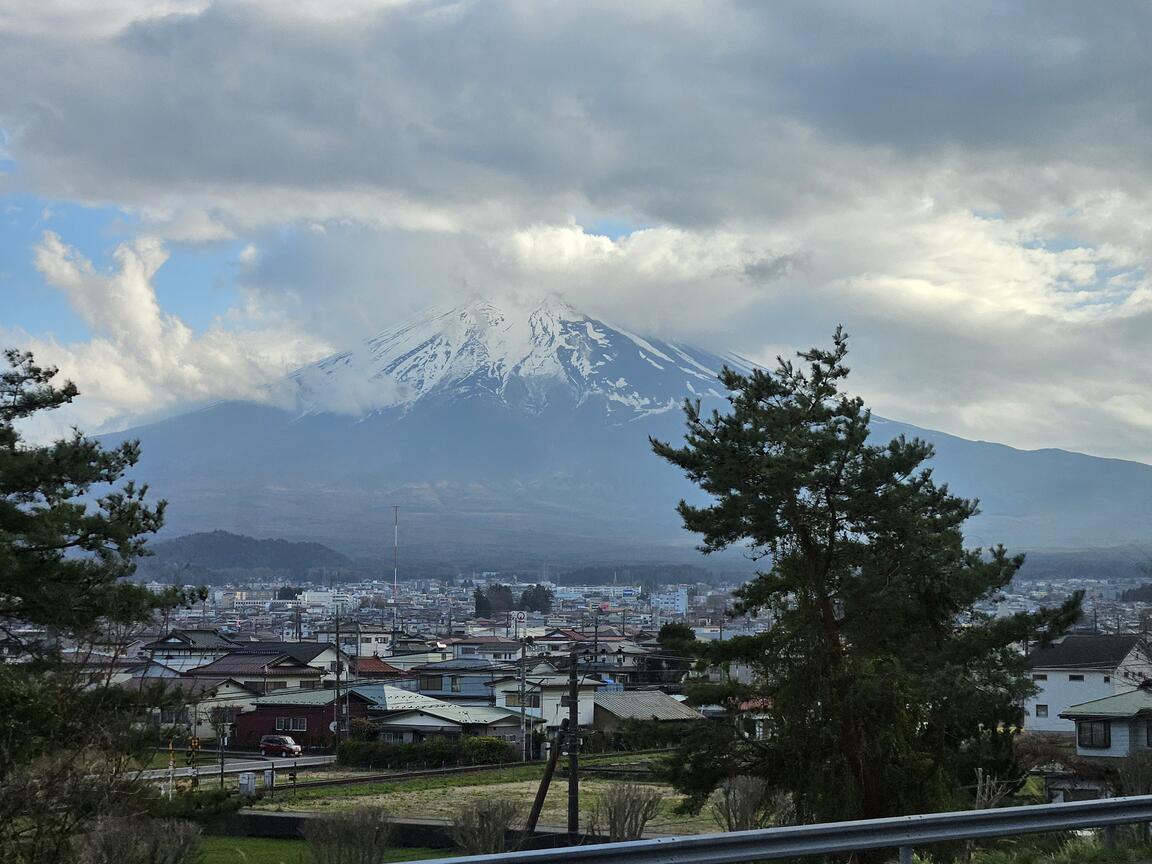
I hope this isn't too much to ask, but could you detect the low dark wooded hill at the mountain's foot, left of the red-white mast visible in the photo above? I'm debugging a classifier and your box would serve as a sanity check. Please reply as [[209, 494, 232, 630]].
[[151, 531, 353, 573]]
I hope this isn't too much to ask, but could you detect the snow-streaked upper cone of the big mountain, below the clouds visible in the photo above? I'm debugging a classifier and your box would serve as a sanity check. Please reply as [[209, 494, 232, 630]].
[[293, 298, 750, 423]]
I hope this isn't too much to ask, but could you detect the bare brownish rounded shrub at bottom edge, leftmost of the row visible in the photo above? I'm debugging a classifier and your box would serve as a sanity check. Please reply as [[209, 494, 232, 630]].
[[76, 817, 200, 864]]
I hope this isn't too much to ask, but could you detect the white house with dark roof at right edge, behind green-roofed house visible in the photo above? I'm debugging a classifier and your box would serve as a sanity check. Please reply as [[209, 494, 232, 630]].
[[1024, 634, 1152, 735]]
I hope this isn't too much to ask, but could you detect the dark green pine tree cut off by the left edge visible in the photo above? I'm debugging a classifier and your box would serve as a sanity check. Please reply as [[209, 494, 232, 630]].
[[0, 350, 170, 634]]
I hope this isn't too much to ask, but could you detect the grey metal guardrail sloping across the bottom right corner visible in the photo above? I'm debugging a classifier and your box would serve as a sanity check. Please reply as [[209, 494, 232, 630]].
[[426, 795, 1152, 864]]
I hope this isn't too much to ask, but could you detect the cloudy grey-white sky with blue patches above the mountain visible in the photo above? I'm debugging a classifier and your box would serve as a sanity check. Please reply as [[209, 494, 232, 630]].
[[0, 0, 1152, 461]]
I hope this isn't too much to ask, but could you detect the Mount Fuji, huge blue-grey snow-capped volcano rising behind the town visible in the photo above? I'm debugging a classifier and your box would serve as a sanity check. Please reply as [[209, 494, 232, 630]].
[[105, 300, 1152, 566]]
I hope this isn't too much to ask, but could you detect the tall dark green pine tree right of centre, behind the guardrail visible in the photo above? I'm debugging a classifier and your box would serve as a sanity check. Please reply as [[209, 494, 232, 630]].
[[652, 328, 1079, 821]]
